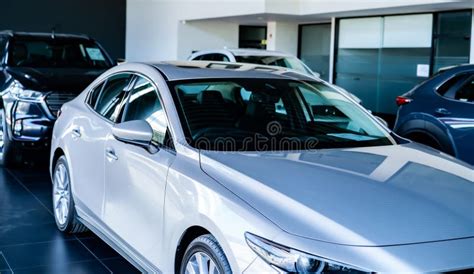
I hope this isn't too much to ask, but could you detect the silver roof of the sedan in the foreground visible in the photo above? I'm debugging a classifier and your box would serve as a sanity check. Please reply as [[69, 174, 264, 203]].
[[151, 61, 315, 81]]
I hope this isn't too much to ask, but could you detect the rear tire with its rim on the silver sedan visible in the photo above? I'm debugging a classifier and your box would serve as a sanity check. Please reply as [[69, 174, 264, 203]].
[[52, 156, 87, 234]]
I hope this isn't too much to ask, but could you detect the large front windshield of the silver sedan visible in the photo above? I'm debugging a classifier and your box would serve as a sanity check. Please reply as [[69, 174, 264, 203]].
[[170, 78, 395, 151]]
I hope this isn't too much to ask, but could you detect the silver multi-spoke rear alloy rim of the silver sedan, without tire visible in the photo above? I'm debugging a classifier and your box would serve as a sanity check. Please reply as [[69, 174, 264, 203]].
[[53, 163, 71, 226]]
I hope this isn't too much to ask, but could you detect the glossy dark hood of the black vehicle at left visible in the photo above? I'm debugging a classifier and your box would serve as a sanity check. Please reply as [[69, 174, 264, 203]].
[[7, 67, 104, 93]]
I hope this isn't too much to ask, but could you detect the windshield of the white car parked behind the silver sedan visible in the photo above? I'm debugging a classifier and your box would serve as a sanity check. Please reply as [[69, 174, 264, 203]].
[[235, 56, 313, 75]]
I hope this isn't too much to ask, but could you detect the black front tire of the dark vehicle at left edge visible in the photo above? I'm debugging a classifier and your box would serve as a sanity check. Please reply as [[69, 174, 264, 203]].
[[1, 109, 23, 168]]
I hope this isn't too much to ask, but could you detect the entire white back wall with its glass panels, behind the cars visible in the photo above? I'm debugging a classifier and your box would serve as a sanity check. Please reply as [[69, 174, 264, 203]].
[[126, 0, 474, 115]]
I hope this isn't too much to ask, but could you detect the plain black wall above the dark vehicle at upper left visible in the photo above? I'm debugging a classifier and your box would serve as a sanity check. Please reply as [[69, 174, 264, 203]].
[[0, 0, 126, 58]]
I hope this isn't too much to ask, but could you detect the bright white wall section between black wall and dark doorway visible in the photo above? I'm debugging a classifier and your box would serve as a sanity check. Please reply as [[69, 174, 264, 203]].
[[125, 0, 265, 61]]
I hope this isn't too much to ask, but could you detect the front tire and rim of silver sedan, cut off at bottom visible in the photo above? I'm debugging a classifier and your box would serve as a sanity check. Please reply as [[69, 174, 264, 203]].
[[179, 234, 232, 274]]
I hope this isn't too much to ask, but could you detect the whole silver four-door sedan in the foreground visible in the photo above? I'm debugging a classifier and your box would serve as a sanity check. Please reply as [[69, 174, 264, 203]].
[[51, 62, 474, 273]]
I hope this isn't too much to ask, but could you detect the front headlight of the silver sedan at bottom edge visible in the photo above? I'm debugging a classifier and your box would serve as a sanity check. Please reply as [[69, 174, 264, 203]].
[[245, 232, 370, 273]]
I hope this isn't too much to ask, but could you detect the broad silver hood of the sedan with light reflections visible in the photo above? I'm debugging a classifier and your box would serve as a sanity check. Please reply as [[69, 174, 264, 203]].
[[201, 143, 474, 246]]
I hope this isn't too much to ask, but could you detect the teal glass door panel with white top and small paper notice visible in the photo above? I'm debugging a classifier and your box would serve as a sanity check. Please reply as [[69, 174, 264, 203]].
[[335, 14, 433, 115]]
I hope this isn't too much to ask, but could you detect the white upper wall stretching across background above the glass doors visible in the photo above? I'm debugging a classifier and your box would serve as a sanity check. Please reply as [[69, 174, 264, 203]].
[[126, 0, 474, 62]]
